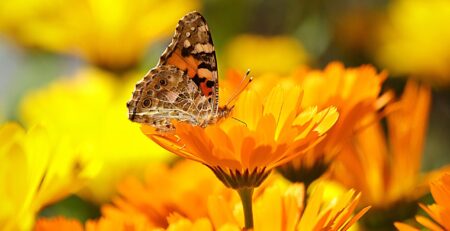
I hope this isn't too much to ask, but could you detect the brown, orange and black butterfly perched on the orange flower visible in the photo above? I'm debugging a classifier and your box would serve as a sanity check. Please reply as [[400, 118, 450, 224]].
[[127, 12, 236, 131]]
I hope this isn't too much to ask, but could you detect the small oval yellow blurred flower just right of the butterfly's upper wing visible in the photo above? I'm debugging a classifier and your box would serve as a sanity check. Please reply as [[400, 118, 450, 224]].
[[225, 34, 307, 75]]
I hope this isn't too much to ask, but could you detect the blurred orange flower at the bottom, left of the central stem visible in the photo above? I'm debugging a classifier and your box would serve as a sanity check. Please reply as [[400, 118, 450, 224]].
[[36, 160, 227, 231]]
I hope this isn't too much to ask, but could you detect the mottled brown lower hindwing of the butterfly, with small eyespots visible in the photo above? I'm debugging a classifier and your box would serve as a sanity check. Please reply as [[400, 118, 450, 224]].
[[128, 65, 212, 130]]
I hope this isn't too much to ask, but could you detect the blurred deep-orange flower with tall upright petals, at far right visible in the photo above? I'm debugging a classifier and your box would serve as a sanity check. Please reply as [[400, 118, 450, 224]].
[[333, 81, 442, 226]]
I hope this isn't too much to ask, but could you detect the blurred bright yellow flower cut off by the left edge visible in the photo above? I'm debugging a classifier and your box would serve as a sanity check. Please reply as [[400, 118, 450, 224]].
[[0, 123, 98, 230]]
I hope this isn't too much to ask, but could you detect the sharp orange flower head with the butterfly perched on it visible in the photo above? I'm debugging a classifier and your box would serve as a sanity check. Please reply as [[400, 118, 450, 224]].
[[142, 85, 338, 189]]
